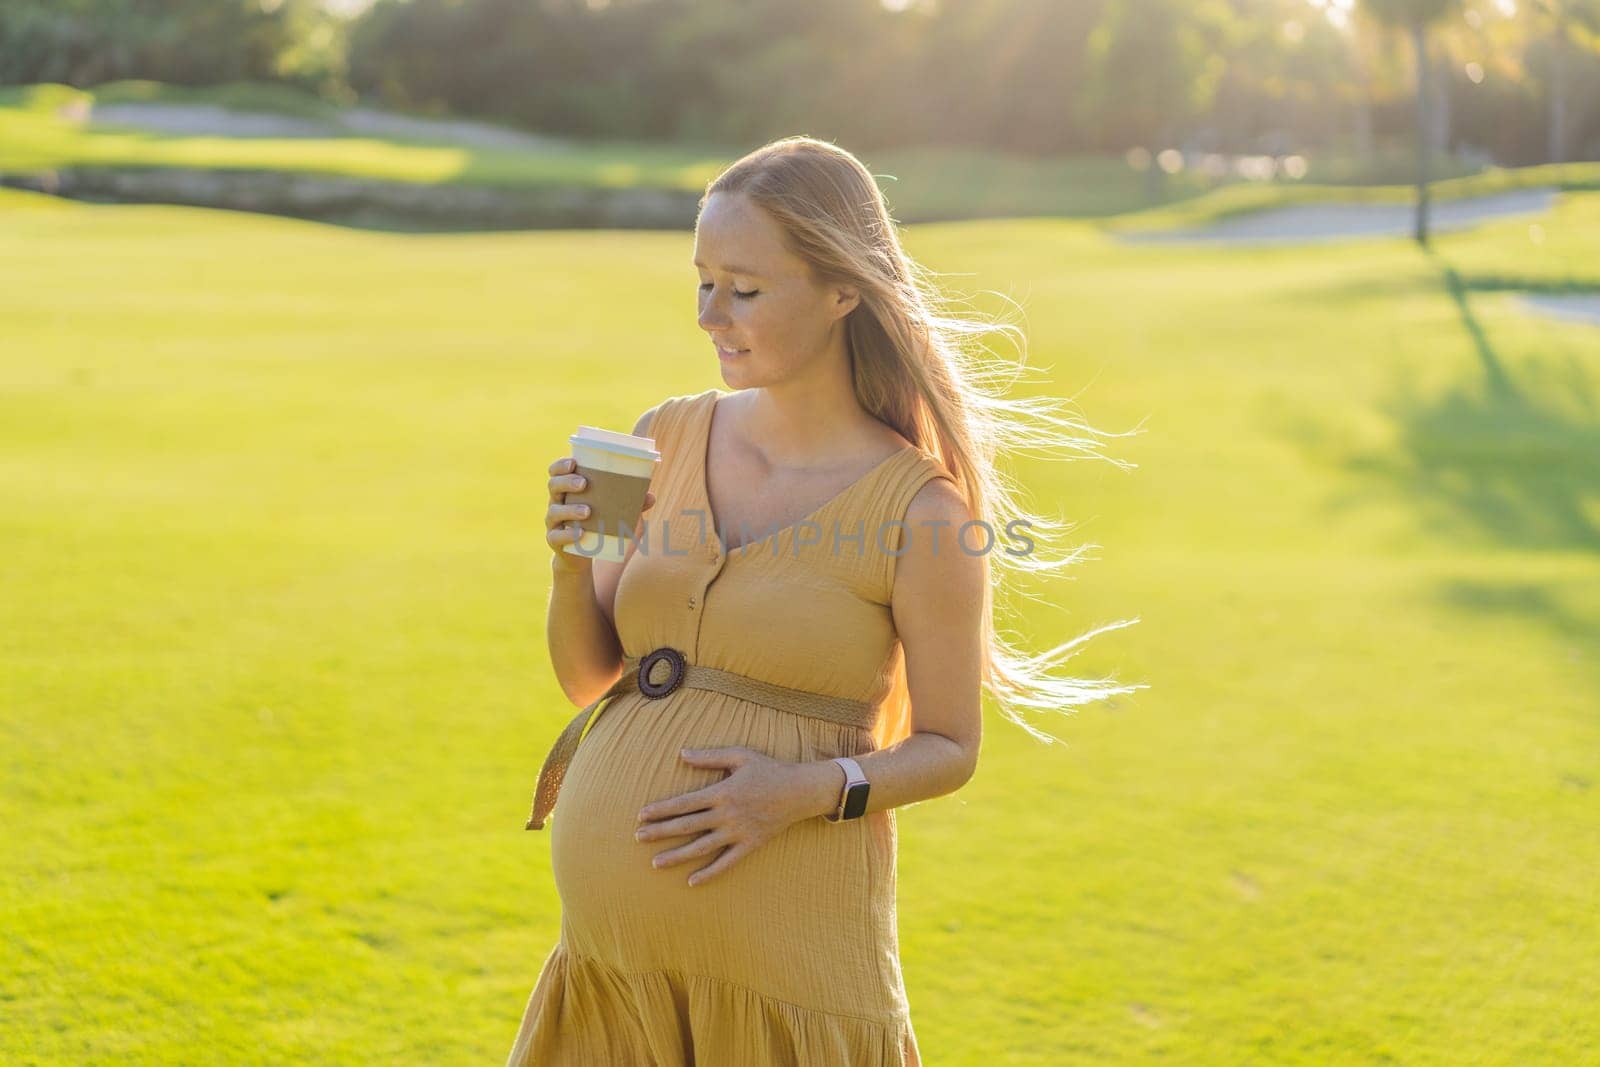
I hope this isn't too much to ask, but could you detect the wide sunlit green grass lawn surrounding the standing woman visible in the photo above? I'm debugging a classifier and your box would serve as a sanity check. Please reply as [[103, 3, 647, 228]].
[[0, 192, 1600, 1067]]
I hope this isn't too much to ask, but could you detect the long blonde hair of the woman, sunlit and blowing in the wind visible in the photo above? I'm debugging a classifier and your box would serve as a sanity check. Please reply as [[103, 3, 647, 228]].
[[699, 136, 1149, 747]]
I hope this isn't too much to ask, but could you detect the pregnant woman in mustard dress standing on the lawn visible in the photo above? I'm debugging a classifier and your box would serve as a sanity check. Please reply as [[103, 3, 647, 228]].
[[507, 138, 1145, 1067]]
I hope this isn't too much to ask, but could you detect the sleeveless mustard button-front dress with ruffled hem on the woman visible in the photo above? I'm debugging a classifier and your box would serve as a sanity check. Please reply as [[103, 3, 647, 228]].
[[507, 389, 949, 1067]]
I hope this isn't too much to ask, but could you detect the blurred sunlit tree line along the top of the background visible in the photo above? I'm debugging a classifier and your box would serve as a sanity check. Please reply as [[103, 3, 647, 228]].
[[0, 0, 1600, 165]]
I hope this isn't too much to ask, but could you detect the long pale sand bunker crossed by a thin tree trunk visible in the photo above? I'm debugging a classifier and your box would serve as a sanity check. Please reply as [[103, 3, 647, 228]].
[[1122, 187, 1557, 245]]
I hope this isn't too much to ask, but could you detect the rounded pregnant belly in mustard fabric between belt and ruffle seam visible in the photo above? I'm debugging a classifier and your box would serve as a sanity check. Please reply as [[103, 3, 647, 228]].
[[550, 689, 894, 973]]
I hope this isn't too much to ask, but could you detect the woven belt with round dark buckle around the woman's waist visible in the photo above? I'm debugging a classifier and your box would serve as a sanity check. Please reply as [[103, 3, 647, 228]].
[[523, 645, 877, 830]]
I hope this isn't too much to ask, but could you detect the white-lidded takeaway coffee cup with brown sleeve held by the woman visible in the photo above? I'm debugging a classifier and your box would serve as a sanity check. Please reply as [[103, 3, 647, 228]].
[[562, 426, 661, 563]]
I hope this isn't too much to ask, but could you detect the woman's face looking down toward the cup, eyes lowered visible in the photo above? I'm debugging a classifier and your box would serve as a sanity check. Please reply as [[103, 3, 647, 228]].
[[694, 192, 859, 389]]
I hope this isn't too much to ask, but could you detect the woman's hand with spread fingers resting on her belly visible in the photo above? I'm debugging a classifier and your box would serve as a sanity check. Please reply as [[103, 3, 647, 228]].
[[634, 747, 805, 886]]
